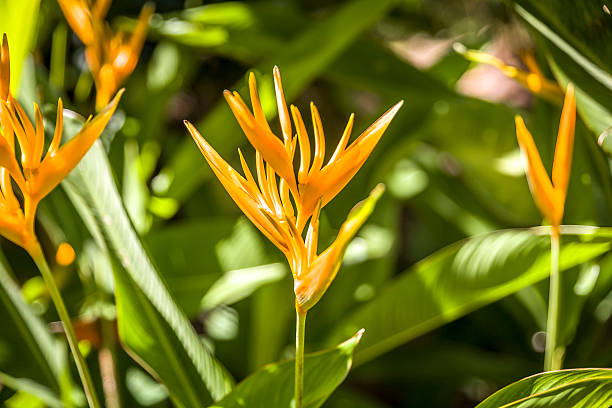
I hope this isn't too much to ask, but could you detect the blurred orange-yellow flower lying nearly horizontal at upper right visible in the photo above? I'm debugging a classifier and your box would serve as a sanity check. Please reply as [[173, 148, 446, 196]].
[[454, 43, 563, 104]]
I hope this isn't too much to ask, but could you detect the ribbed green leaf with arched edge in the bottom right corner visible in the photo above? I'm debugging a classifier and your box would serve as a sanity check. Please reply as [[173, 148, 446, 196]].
[[476, 368, 612, 408]]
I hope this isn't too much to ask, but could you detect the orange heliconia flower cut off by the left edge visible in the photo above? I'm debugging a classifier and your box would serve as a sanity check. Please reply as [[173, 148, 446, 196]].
[[0, 35, 123, 250]]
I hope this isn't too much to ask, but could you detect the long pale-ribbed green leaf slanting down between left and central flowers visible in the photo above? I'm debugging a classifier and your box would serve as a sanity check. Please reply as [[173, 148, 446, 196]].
[[62, 111, 231, 407]]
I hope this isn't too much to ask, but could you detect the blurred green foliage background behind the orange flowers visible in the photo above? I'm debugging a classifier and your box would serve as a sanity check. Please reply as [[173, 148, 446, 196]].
[[0, 0, 612, 408]]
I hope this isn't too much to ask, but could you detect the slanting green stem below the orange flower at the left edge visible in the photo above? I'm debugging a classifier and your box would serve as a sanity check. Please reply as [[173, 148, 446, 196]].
[[28, 242, 101, 408]]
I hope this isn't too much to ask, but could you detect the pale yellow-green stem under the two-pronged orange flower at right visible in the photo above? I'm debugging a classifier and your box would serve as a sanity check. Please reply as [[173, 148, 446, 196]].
[[544, 227, 563, 371]]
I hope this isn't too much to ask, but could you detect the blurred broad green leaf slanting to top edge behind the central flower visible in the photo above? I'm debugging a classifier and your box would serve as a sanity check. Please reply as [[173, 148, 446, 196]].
[[161, 0, 395, 198]]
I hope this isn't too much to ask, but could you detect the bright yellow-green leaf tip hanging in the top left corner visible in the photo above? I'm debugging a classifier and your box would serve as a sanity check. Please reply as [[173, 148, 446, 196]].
[[0, 0, 40, 95]]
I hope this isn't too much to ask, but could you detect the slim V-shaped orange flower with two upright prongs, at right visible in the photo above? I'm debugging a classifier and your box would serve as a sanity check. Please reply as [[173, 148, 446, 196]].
[[515, 84, 576, 231]]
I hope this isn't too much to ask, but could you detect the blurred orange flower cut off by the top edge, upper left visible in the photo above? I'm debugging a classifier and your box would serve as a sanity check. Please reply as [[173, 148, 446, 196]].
[[58, 0, 154, 109]]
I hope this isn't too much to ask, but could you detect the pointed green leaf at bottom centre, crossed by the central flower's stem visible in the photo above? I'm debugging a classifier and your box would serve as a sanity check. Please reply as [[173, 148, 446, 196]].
[[211, 330, 363, 408]]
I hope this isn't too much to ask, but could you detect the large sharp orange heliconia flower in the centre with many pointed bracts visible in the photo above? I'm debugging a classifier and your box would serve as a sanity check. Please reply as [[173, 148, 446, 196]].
[[185, 67, 402, 312]]
